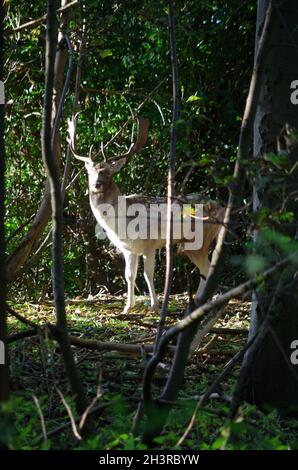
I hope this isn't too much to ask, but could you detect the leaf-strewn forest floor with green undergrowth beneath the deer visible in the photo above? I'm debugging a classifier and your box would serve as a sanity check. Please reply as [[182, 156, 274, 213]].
[[5, 295, 298, 450]]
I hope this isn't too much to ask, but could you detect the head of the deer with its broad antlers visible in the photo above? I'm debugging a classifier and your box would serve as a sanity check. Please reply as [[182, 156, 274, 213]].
[[68, 115, 149, 196]]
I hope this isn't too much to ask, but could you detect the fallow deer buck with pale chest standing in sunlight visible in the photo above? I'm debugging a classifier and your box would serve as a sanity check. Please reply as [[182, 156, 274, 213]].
[[68, 116, 223, 312]]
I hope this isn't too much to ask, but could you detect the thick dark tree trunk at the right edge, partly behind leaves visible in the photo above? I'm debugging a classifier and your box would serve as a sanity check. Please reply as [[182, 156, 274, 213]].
[[239, 0, 298, 414]]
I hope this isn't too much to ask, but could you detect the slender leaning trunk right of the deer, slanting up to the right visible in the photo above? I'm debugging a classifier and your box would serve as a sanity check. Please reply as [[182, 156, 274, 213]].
[[135, 0, 272, 442]]
